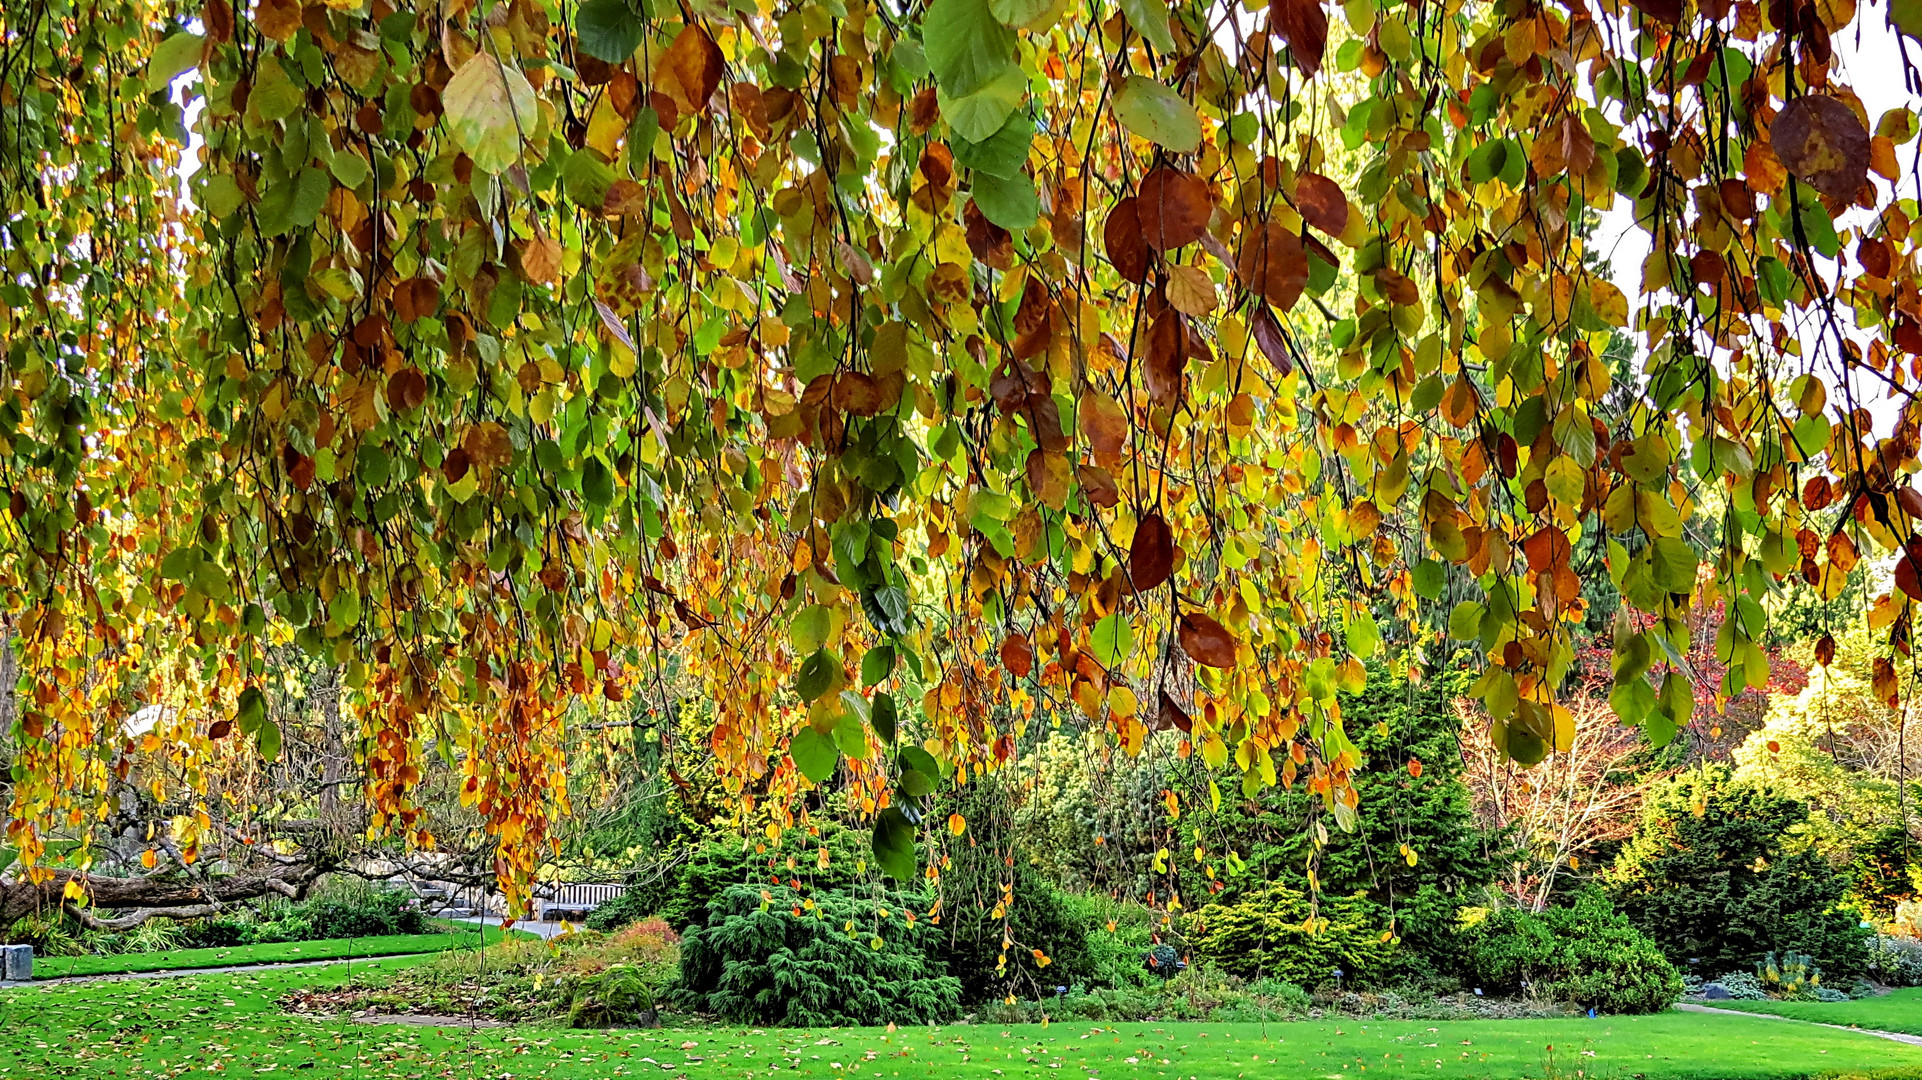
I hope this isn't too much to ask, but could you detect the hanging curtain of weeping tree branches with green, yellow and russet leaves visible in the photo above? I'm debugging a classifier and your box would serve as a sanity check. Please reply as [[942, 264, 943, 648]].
[[0, 0, 1922, 899]]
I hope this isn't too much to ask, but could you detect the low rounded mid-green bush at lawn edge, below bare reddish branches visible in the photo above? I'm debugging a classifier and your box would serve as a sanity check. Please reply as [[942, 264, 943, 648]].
[[1463, 892, 1682, 1013]]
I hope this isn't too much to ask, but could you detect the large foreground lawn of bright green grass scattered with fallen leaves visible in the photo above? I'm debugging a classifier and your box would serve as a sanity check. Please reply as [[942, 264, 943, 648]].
[[0, 957, 1922, 1080]]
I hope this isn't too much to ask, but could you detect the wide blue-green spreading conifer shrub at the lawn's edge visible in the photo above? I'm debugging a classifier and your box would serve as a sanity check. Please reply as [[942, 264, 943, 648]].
[[678, 886, 961, 1028]]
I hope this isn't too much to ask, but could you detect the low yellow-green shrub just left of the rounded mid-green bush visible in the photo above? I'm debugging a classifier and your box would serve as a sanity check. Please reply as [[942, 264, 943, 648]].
[[1194, 882, 1395, 988]]
